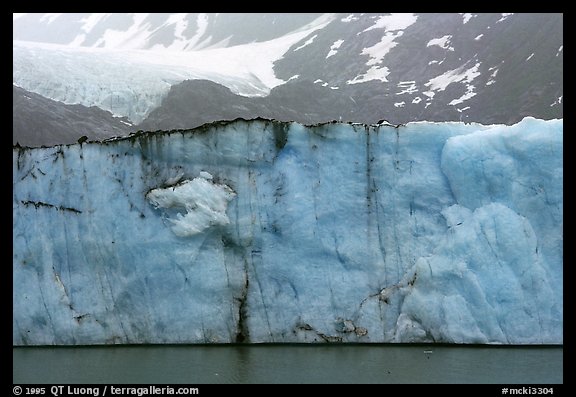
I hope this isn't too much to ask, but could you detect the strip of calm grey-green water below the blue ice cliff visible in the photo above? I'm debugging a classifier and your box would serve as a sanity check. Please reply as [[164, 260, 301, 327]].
[[13, 345, 563, 384]]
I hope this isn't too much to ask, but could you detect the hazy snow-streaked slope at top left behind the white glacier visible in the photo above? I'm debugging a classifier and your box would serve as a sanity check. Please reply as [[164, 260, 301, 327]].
[[13, 13, 331, 51]]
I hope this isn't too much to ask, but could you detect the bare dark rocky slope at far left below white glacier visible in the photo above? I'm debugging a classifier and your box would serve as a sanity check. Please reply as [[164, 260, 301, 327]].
[[12, 87, 136, 146]]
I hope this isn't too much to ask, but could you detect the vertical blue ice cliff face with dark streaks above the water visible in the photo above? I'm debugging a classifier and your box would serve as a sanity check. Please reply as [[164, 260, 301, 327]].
[[13, 118, 563, 345]]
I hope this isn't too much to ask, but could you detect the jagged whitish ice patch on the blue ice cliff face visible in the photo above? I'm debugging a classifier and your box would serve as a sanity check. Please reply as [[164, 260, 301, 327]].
[[146, 171, 236, 237]]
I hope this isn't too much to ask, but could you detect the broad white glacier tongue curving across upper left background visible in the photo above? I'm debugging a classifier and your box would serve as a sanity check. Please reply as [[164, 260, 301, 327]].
[[13, 14, 329, 123]]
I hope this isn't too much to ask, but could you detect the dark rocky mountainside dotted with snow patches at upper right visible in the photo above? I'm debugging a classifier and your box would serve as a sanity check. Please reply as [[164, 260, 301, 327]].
[[142, 14, 563, 129]]
